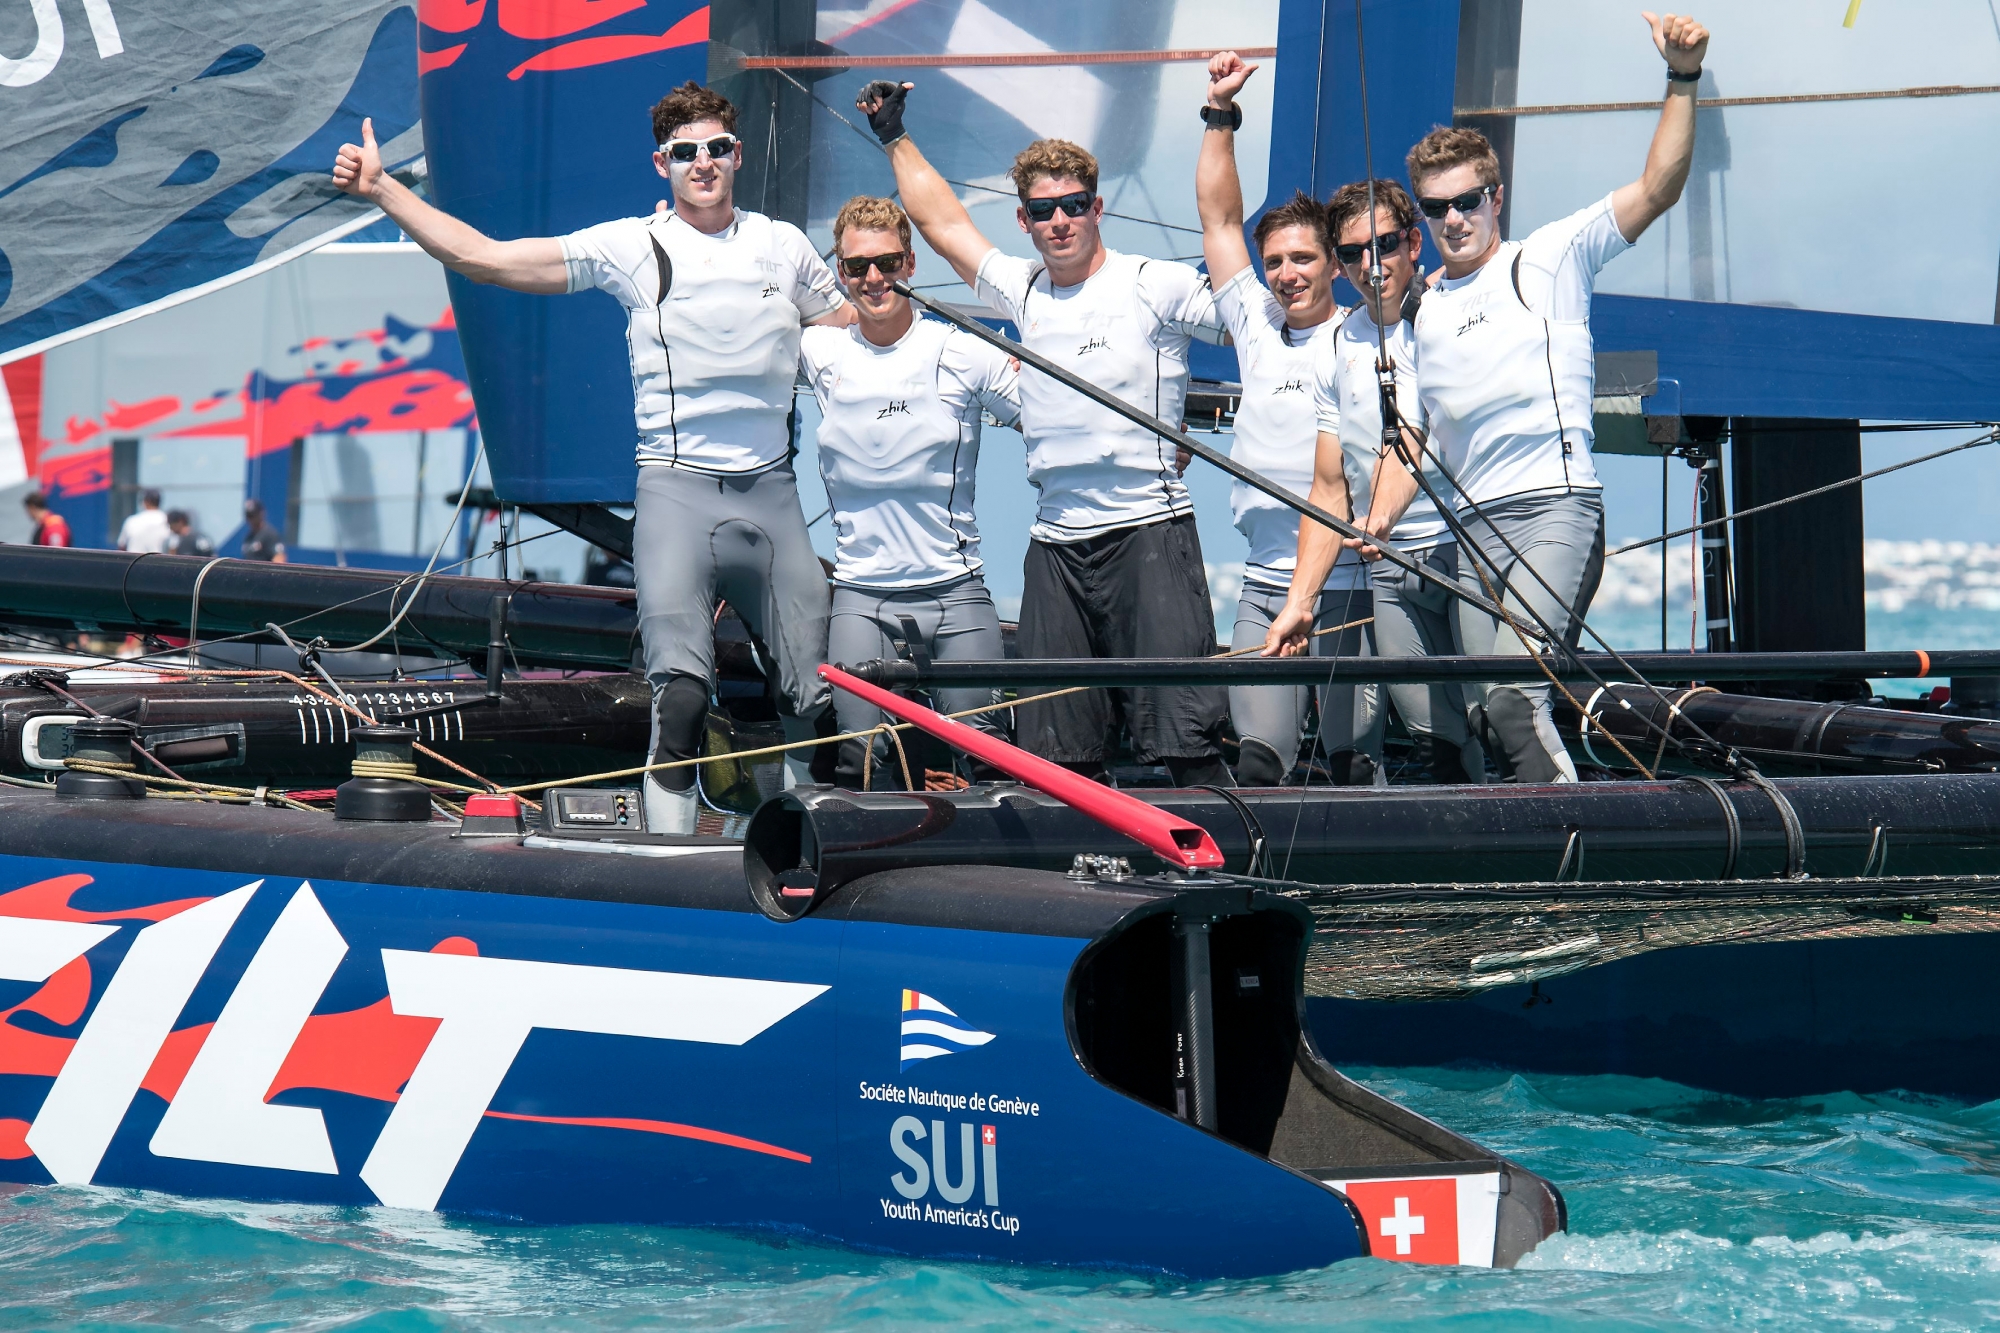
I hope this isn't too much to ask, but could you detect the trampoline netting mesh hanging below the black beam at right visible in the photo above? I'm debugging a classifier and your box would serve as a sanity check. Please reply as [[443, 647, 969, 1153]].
[[1282, 879, 2000, 999]]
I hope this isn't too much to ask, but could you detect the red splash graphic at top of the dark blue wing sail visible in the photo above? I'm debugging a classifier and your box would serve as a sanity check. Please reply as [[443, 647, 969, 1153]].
[[416, 0, 708, 80]]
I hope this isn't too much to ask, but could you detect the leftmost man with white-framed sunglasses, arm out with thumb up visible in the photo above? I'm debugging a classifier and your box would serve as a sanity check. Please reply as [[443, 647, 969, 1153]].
[[334, 82, 854, 833]]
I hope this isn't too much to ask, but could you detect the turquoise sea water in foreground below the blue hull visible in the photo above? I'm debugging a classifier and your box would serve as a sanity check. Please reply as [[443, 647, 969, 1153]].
[[0, 1069, 2000, 1333]]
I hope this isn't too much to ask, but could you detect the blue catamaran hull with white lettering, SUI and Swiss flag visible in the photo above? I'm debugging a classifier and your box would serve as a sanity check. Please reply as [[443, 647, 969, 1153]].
[[0, 795, 1560, 1277]]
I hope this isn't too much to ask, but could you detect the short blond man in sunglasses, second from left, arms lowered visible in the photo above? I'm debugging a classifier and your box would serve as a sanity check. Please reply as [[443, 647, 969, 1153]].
[[800, 196, 1020, 789]]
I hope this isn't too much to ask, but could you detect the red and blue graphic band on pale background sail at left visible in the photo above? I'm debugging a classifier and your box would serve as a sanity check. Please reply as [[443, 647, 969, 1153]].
[[40, 308, 478, 498]]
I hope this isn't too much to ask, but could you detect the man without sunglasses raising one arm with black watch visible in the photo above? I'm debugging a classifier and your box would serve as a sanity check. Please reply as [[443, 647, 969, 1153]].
[[1194, 50, 1374, 787]]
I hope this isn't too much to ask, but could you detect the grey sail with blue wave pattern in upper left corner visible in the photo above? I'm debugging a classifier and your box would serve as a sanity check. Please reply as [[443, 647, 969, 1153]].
[[0, 0, 422, 362]]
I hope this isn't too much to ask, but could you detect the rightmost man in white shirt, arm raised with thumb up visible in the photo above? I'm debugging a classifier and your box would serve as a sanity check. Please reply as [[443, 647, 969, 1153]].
[[1366, 14, 1708, 783]]
